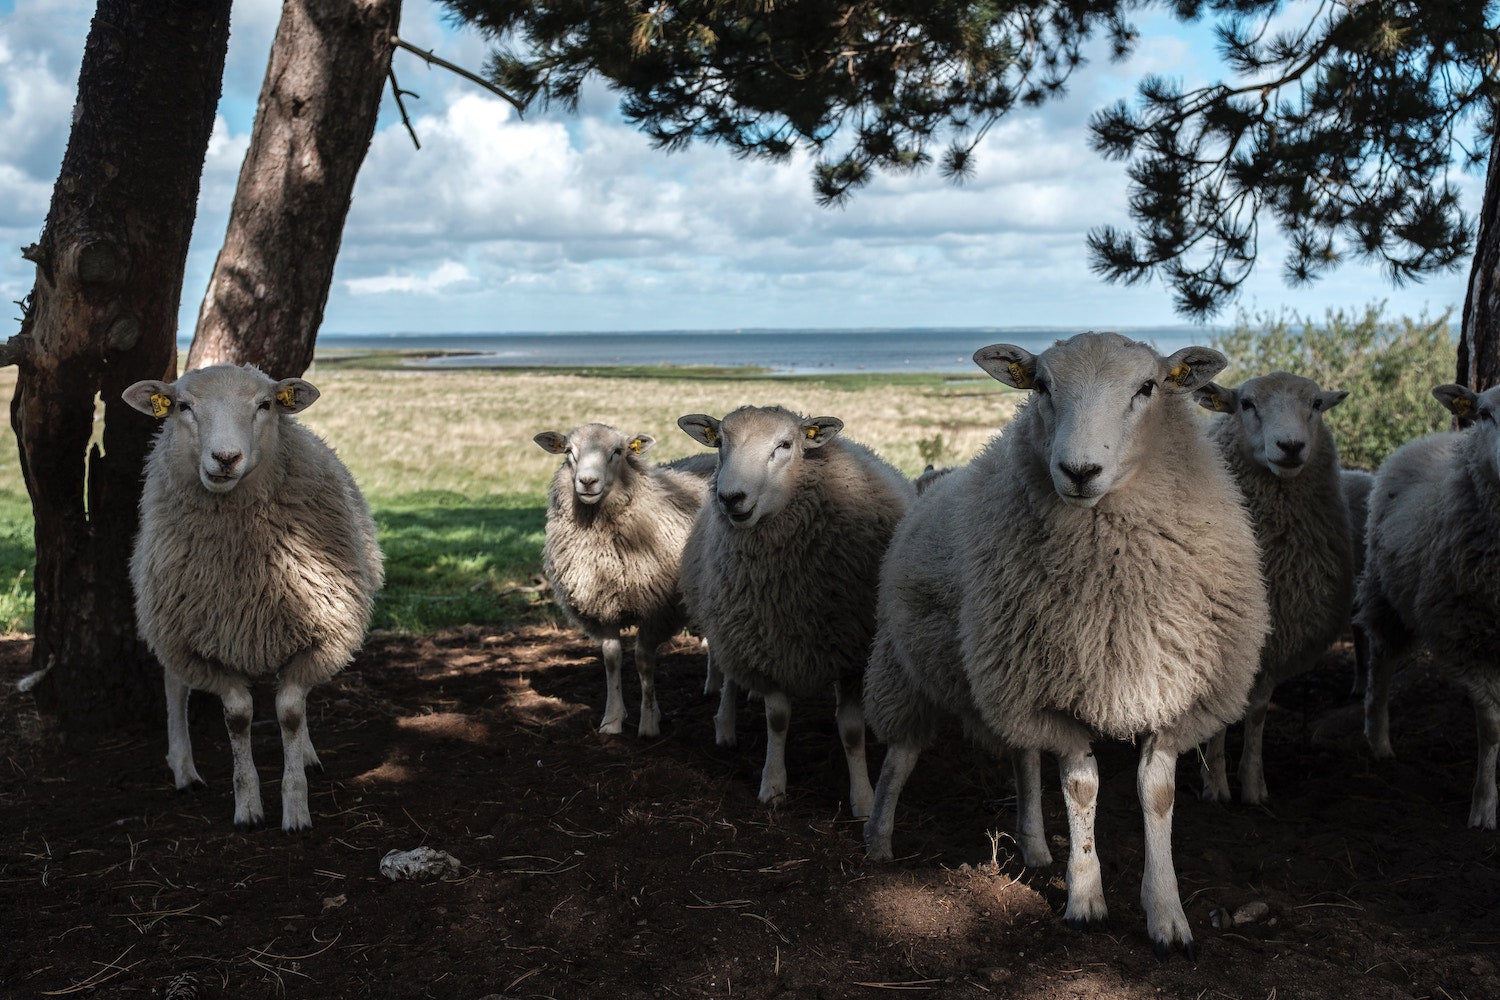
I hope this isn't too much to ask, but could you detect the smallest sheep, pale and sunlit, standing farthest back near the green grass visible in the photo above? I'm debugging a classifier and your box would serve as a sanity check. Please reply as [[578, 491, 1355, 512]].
[[533, 423, 713, 739]]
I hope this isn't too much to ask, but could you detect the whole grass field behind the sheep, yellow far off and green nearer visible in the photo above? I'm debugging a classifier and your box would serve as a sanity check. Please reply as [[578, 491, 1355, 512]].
[[0, 355, 1020, 633]]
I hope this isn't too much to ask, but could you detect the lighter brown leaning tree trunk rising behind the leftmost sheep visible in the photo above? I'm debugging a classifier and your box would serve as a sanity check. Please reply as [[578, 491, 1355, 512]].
[[188, 0, 401, 378]]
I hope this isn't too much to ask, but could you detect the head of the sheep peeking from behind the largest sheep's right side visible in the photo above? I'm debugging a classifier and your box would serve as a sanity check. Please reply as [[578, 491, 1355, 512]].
[[1193, 372, 1349, 480]]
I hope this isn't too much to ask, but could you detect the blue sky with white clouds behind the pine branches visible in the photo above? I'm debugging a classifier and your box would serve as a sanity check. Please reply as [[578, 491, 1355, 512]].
[[0, 0, 1484, 337]]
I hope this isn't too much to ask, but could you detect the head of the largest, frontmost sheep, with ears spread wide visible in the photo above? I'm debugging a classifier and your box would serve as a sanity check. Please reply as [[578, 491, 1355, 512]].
[[974, 333, 1227, 507]]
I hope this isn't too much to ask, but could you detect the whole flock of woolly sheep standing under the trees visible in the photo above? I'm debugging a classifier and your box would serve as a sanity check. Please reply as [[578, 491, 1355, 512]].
[[125, 333, 1500, 955]]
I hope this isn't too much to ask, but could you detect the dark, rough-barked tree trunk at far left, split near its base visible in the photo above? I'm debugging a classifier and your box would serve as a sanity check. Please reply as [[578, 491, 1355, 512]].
[[11, 0, 230, 733]]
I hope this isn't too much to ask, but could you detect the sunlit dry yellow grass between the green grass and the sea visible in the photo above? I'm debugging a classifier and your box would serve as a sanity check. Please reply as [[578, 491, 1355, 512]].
[[303, 366, 1022, 496]]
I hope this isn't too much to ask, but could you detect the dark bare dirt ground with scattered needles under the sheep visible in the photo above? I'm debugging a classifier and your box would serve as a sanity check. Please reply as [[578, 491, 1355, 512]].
[[0, 628, 1500, 1000]]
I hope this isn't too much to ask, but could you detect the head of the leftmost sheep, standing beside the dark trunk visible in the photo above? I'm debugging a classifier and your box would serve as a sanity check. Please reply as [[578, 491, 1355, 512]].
[[125, 364, 318, 493]]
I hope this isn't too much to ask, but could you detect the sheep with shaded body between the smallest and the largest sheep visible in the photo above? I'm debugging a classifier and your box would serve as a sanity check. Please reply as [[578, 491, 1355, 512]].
[[678, 406, 917, 817]]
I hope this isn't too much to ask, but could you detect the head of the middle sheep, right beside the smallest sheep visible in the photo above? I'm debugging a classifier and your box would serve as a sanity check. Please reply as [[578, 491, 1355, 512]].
[[677, 406, 843, 529]]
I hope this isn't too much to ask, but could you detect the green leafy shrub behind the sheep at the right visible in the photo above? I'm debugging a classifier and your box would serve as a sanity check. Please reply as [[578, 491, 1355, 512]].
[[1212, 303, 1457, 469]]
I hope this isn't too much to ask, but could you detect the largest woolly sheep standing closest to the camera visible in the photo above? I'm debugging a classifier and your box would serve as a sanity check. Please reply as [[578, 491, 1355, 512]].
[[866, 333, 1269, 957]]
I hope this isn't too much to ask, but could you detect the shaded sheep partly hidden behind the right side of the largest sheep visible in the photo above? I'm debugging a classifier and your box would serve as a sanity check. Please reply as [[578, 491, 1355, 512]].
[[1194, 372, 1355, 805]]
